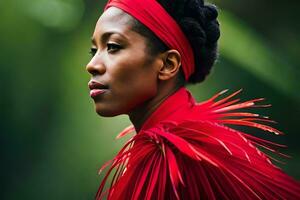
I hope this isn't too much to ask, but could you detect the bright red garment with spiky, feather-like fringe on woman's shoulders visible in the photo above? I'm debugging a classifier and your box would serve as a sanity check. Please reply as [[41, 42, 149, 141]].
[[96, 88, 300, 200]]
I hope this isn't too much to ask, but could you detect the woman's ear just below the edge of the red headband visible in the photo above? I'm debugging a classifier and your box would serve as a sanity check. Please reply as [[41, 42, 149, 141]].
[[158, 49, 181, 80]]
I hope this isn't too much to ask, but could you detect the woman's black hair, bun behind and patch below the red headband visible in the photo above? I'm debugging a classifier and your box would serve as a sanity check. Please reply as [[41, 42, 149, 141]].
[[132, 0, 220, 84]]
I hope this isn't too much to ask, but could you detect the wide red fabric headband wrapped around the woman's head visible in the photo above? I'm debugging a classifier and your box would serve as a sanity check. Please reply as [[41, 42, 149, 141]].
[[104, 0, 194, 80]]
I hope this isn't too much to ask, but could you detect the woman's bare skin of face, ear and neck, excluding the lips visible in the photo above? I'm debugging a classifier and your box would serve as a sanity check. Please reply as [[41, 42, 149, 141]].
[[86, 7, 181, 132]]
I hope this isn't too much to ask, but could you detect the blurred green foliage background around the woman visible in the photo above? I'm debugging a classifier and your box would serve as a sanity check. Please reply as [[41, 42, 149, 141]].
[[0, 0, 300, 200]]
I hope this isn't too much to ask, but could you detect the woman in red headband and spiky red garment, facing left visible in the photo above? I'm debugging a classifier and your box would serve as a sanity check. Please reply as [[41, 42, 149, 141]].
[[87, 0, 300, 199]]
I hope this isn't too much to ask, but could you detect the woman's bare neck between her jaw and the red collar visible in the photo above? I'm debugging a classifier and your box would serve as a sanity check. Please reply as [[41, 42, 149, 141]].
[[128, 83, 180, 133]]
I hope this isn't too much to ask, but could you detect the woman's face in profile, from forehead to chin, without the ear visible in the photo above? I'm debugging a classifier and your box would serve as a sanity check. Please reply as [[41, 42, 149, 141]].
[[86, 7, 163, 116]]
